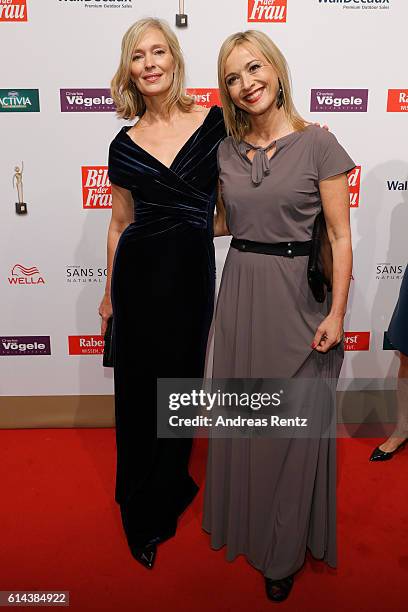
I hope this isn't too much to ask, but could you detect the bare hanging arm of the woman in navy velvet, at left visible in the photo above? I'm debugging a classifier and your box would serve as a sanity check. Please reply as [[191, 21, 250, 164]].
[[99, 184, 133, 335]]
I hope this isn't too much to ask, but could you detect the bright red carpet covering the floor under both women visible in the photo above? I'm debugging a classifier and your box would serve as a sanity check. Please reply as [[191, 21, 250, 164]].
[[0, 429, 408, 612]]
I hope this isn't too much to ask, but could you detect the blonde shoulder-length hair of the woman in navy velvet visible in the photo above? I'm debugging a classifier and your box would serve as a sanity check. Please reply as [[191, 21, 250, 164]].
[[111, 17, 194, 119]]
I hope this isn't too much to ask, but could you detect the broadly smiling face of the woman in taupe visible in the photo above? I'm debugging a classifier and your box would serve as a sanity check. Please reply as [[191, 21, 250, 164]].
[[224, 44, 279, 115]]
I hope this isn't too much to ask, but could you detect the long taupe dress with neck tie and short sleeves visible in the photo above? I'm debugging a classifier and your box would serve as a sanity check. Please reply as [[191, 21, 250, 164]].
[[203, 126, 355, 579]]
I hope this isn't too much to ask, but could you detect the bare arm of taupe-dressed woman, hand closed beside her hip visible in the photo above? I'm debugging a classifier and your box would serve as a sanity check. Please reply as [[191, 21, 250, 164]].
[[312, 174, 353, 353]]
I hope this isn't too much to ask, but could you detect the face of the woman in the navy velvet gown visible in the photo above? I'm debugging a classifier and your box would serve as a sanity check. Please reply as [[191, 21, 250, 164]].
[[131, 28, 175, 96]]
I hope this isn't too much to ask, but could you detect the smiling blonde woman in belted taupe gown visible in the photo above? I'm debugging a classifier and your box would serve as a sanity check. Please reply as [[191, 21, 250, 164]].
[[203, 31, 355, 601]]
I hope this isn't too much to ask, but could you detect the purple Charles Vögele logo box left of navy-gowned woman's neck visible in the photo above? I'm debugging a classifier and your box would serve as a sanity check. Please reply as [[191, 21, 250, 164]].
[[60, 87, 115, 113]]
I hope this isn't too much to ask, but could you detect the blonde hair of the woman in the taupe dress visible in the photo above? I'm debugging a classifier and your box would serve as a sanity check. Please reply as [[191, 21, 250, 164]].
[[218, 30, 307, 142]]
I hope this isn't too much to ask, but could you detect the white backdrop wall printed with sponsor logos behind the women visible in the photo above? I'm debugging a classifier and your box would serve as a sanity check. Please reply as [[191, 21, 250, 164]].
[[0, 0, 408, 396]]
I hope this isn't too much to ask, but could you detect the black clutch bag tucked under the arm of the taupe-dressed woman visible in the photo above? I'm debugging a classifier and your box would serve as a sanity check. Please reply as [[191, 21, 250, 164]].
[[307, 211, 333, 303]]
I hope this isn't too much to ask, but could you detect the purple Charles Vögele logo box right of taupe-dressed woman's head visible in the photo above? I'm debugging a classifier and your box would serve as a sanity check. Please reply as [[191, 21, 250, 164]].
[[310, 89, 368, 113]]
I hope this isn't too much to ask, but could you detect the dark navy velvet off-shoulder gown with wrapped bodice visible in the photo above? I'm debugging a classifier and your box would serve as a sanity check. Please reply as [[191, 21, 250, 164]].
[[109, 106, 226, 548]]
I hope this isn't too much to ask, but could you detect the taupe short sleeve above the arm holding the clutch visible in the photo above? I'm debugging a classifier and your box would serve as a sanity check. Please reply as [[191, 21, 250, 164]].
[[315, 128, 356, 181]]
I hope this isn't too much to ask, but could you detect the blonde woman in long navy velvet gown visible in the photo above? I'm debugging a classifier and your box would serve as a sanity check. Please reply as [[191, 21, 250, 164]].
[[99, 19, 226, 568]]
